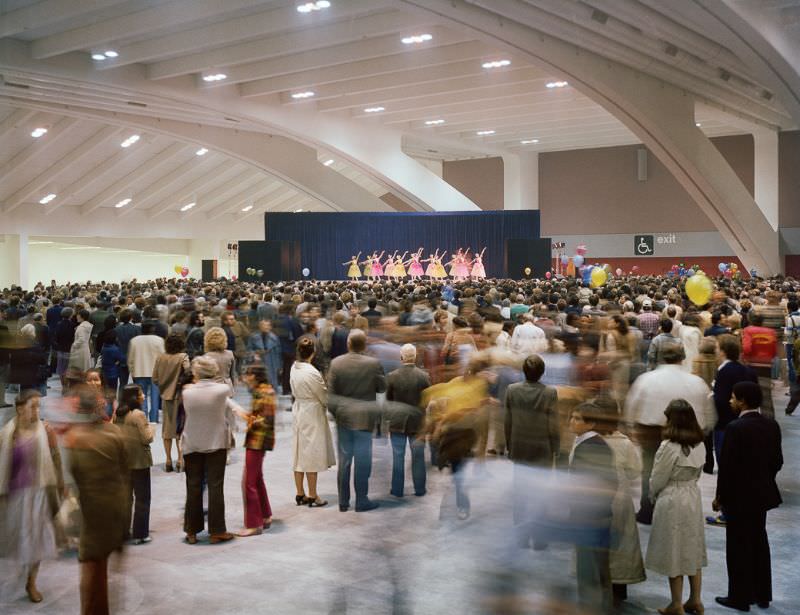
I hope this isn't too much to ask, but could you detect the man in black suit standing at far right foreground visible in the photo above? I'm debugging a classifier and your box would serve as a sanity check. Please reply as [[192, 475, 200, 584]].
[[714, 382, 783, 611]]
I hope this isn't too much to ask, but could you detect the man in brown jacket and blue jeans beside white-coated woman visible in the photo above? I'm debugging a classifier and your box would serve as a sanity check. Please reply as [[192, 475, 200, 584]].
[[328, 329, 386, 512]]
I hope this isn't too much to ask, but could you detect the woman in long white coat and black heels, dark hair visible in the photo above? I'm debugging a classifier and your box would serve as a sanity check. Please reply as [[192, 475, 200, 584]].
[[289, 337, 336, 508]]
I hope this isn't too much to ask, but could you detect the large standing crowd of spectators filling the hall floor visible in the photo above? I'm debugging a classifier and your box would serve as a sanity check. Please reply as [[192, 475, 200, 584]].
[[0, 276, 800, 615]]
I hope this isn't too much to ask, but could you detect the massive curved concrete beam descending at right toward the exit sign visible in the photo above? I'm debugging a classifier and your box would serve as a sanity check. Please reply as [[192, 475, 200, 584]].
[[398, 0, 781, 275]]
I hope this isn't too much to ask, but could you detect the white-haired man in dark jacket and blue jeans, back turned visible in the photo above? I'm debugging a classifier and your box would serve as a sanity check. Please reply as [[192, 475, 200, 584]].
[[386, 344, 431, 497]]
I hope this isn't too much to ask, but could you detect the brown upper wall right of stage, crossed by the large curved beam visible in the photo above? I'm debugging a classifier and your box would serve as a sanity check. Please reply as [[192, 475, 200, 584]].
[[539, 135, 754, 235]]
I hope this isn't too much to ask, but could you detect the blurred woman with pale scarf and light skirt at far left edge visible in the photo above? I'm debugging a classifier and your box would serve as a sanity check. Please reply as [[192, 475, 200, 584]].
[[0, 389, 64, 602]]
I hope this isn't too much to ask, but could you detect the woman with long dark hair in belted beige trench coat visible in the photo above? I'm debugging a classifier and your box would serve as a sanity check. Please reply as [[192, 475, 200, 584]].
[[645, 399, 708, 615]]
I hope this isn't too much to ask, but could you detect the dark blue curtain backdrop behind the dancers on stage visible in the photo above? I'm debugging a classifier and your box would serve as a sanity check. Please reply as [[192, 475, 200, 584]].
[[264, 210, 540, 280]]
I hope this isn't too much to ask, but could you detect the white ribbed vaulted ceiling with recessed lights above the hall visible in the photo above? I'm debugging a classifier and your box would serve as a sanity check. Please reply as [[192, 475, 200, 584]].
[[0, 0, 800, 229]]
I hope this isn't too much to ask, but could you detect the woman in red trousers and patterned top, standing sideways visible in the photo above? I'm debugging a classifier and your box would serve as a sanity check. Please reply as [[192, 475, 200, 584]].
[[234, 365, 276, 536]]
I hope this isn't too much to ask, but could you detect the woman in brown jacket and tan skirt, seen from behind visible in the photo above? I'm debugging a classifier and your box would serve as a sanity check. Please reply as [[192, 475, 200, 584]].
[[153, 333, 191, 472]]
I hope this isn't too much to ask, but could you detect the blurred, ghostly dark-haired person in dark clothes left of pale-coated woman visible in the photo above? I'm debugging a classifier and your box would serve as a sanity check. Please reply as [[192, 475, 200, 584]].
[[569, 401, 617, 612]]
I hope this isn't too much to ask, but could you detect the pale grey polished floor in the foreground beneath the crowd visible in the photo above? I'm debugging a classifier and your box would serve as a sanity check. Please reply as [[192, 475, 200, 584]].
[[0, 382, 800, 615]]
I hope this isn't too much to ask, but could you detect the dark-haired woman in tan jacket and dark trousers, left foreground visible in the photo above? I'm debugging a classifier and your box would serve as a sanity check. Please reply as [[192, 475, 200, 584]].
[[114, 384, 154, 545]]
